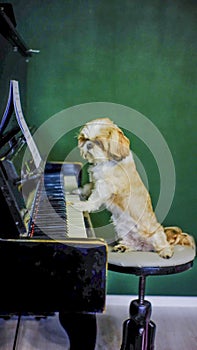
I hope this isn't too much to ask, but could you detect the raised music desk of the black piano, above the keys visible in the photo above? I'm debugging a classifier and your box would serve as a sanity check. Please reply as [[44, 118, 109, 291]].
[[0, 80, 44, 237]]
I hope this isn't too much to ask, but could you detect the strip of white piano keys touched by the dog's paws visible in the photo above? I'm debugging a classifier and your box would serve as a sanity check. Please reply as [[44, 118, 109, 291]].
[[64, 176, 87, 238]]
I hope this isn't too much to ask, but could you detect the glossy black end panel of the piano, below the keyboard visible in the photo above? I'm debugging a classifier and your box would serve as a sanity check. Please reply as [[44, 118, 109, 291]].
[[0, 239, 106, 314]]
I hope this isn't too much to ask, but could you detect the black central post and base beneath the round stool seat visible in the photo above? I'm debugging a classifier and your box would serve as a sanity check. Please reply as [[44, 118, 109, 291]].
[[121, 276, 156, 350]]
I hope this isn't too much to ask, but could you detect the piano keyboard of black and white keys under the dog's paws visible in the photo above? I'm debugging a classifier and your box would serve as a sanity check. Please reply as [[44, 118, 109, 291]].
[[29, 172, 87, 240]]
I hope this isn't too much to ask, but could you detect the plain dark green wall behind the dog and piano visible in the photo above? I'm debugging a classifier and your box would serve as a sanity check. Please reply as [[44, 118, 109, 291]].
[[3, 0, 197, 295]]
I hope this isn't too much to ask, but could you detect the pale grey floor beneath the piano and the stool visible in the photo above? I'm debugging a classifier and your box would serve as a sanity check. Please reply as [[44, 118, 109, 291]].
[[0, 300, 197, 350]]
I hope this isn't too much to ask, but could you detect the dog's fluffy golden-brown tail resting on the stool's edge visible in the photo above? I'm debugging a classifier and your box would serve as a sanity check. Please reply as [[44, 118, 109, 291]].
[[164, 226, 196, 249]]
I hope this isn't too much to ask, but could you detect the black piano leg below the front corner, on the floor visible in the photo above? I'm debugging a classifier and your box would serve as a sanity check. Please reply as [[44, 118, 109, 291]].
[[59, 312, 97, 350]]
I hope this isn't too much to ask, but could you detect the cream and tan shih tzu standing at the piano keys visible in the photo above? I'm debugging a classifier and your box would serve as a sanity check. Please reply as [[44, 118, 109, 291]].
[[73, 118, 194, 258]]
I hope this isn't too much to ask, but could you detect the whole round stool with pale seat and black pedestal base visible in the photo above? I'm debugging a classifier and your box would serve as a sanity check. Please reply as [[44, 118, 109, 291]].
[[108, 246, 195, 350]]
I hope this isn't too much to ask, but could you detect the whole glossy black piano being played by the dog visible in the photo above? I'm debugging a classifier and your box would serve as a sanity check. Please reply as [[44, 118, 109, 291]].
[[0, 7, 107, 350]]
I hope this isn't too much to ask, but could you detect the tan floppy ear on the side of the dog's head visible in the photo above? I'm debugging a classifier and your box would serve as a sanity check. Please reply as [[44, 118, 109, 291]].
[[108, 128, 130, 161]]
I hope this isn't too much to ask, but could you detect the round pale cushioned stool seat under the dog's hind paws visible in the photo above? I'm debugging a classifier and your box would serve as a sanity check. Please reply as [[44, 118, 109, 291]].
[[108, 245, 196, 275]]
